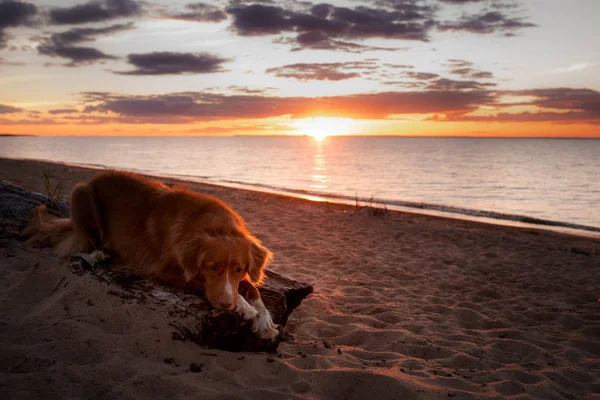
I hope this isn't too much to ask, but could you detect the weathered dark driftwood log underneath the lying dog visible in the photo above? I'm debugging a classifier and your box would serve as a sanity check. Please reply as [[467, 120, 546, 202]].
[[0, 181, 313, 352]]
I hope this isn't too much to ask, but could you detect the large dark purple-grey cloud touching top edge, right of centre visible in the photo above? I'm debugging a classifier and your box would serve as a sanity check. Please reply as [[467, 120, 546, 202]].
[[226, 0, 536, 52]]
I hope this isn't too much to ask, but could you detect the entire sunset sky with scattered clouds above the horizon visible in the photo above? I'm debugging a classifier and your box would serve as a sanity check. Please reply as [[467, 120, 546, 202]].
[[0, 0, 600, 137]]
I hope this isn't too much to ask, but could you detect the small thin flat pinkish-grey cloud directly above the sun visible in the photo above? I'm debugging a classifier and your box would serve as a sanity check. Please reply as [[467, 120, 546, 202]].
[[265, 61, 377, 81]]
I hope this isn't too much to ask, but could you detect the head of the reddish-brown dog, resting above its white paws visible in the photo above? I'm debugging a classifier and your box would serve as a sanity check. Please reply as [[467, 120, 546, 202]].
[[178, 234, 273, 310]]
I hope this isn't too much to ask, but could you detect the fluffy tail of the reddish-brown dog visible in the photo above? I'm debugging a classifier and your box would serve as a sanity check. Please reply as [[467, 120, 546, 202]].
[[22, 206, 89, 257]]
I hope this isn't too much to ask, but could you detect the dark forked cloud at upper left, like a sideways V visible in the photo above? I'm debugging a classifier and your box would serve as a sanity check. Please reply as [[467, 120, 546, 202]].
[[38, 23, 134, 67]]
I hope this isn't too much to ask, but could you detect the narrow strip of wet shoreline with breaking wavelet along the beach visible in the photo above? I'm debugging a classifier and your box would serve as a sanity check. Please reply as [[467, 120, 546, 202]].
[[0, 157, 600, 239]]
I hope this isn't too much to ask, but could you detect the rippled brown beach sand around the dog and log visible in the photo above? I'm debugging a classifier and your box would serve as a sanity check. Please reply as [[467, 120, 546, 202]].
[[0, 160, 600, 400]]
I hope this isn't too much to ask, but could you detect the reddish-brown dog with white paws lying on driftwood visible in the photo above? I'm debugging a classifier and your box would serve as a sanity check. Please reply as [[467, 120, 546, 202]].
[[24, 171, 279, 339]]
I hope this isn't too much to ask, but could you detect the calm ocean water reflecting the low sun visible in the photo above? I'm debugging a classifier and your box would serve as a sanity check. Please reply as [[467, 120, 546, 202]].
[[0, 136, 600, 228]]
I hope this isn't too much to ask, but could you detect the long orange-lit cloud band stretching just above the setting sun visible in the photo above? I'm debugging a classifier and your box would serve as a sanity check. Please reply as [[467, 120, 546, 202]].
[[21, 87, 600, 126]]
